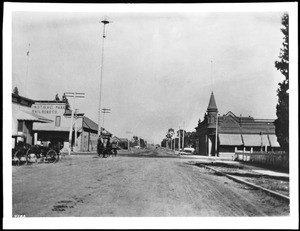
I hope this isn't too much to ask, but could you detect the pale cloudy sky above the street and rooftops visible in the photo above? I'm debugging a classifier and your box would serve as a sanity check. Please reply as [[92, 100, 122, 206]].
[[11, 4, 290, 143]]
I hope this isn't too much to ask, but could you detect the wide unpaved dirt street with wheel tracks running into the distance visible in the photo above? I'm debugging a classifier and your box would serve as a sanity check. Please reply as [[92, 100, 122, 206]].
[[13, 149, 289, 217]]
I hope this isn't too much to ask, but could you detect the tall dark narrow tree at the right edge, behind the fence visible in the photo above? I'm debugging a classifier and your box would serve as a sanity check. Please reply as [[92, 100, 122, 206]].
[[275, 13, 289, 152]]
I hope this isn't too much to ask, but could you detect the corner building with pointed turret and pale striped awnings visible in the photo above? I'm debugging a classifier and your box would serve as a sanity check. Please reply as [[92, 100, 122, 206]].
[[196, 93, 280, 159]]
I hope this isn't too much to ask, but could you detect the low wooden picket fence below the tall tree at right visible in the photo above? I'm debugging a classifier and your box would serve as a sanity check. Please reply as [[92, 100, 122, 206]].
[[234, 152, 289, 169]]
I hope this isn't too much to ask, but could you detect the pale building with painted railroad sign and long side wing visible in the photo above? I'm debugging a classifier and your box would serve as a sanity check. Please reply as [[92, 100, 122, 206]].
[[31, 100, 102, 152]]
